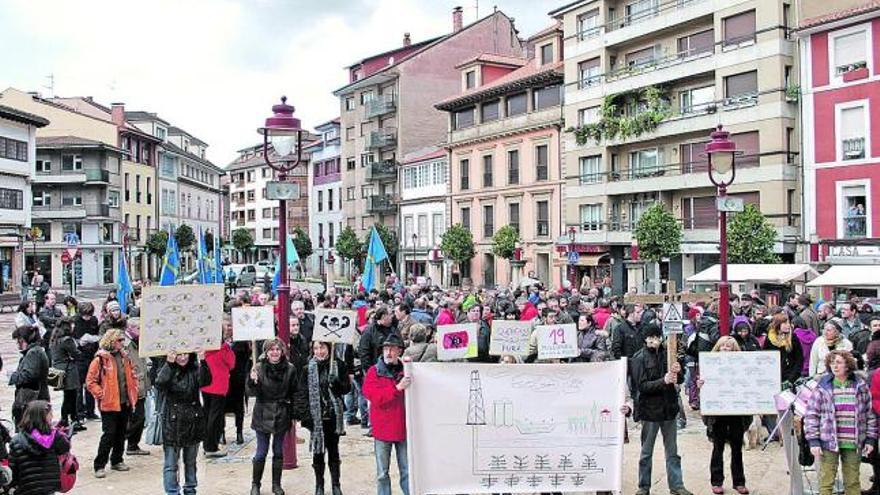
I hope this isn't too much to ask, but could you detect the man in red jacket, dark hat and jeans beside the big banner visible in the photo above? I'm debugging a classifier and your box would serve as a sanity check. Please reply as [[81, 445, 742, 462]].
[[362, 333, 412, 495]]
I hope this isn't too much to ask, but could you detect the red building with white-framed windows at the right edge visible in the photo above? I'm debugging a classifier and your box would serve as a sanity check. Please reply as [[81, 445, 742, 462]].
[[797, 0, 880, 298]]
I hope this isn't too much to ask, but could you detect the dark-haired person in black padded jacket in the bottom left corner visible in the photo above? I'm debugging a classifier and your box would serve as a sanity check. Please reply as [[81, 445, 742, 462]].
[[9, 400, 70, 495]]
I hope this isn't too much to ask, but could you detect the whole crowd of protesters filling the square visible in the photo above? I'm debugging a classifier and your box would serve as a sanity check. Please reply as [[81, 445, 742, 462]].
[[10, 276, 880, 495]]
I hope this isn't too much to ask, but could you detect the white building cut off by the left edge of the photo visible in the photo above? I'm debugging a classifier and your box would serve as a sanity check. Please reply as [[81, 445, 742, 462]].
[[0, 105, 49, 292]]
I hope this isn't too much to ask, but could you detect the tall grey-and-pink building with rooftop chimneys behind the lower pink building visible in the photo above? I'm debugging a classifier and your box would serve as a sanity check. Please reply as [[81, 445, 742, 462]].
[[333, 7, 523, 242]]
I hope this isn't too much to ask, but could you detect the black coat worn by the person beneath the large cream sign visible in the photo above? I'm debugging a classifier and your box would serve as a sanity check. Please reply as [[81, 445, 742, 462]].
[[156, 355, 206, 447]]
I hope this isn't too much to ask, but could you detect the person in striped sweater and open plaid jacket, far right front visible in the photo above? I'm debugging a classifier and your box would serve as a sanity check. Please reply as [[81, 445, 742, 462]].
[[804, 350, 877, 495]]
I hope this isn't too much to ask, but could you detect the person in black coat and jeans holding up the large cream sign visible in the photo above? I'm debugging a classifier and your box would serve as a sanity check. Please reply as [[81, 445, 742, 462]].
[[156, 352, 208, 493]]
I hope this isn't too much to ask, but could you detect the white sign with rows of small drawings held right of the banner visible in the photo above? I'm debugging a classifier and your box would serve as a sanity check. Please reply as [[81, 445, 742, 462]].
[[700, 351, 782, 416]]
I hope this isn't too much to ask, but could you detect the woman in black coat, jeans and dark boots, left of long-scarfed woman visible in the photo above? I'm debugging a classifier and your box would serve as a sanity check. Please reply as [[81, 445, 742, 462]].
[[247, 339, 297, 495]]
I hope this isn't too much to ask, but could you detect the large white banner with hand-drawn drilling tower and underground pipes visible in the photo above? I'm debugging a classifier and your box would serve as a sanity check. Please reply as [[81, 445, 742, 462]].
[[406, 359, 626, 494]]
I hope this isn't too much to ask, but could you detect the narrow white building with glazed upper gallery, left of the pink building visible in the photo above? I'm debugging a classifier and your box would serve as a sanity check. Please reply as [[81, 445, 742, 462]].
[[397, 148, 449, 285]]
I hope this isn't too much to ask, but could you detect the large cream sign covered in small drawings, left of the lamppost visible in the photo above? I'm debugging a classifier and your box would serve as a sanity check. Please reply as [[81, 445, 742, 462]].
[[140, 284, 223, 357]]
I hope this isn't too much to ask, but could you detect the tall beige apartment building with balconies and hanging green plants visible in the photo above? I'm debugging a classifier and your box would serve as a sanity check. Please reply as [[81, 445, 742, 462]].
[[550, 0, 800, 291]]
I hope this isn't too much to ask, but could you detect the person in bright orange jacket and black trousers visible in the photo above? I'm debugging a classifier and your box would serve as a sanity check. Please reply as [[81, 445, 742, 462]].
[[86, 328, 138, 478]]
